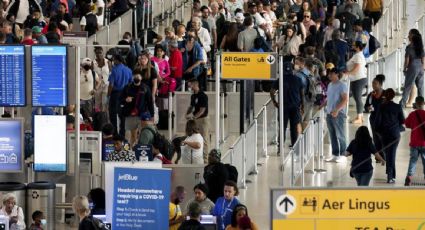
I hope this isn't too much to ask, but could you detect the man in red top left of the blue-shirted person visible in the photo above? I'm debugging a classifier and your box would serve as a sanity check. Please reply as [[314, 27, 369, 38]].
[[168, 39, 183, 89]]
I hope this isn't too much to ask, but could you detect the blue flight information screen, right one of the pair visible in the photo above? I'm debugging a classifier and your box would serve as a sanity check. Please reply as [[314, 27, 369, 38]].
[[31, 46, 67, 106]]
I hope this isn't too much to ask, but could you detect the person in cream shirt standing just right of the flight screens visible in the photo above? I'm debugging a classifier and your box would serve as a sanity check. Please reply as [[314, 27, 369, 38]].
[[80, 58, 100, 117]]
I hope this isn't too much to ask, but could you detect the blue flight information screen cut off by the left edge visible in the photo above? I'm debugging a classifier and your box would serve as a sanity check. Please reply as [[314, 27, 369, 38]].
[[0, 45, 26, 107]]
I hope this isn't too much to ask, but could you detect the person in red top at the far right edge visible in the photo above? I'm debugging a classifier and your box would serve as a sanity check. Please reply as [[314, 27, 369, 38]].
[[404, 96, 425, 186]]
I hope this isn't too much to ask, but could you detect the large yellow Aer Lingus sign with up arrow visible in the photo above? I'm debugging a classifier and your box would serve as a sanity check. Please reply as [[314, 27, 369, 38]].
[[271, 188, 425, 230]]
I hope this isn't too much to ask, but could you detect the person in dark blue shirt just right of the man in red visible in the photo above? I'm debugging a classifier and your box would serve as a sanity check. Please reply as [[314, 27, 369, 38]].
[[183, 36, 204, 78]]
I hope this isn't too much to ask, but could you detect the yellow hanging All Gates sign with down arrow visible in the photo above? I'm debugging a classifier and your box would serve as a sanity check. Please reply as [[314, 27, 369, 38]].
[[221, 52, 277, 80]]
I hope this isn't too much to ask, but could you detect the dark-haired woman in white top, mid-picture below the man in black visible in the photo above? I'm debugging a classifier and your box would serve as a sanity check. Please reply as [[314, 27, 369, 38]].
[[181, 120, 204, 164]]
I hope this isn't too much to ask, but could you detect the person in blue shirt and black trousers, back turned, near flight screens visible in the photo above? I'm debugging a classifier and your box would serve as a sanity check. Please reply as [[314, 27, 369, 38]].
[[108, 55, 133, 136]]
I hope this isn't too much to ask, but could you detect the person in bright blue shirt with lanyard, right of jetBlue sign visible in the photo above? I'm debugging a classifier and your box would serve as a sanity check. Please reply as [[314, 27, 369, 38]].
[[212, 181, 239, 230]]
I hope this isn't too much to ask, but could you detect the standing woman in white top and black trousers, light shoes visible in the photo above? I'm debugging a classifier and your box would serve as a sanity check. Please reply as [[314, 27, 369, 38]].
[[345, 41, 367, 124]]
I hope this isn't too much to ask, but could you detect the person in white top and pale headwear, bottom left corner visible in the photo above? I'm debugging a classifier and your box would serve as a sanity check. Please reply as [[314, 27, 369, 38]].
[[0, 193, 26, 230]]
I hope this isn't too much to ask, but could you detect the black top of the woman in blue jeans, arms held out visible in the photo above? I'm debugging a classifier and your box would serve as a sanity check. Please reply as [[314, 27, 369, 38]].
[[347, 141, 376, 173]]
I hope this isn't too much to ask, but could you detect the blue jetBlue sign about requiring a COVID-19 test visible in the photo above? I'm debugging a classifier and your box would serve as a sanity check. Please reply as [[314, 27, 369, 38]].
[[112, 168, 171, 230]]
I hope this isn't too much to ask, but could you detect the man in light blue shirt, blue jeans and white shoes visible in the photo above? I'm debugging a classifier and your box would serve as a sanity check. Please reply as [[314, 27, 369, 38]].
[[325, 68, 348, 163]]
